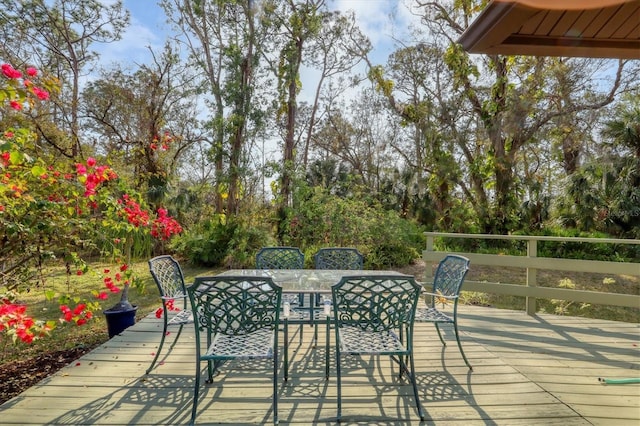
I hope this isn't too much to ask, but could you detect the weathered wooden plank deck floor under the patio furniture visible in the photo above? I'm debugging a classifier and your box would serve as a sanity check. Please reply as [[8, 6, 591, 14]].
[[0, 306, 640, 426]]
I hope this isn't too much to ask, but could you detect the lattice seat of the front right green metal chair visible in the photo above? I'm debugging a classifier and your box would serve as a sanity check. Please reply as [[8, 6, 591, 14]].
[[338, 327, 407, 355]]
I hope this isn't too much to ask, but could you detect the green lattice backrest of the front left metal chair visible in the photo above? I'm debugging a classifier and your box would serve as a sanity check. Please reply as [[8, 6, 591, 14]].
[[187, 276, 282, 338]]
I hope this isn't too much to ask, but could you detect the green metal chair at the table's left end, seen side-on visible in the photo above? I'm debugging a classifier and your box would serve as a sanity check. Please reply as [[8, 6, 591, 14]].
[[147, 255, 193, 374]]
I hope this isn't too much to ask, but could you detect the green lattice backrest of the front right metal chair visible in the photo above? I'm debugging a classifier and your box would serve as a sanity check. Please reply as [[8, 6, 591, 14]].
[[331, 275, 422, 332]]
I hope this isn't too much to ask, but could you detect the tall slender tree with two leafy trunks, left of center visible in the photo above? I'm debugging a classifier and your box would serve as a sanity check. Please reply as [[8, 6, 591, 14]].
[[162, 0, 261, 215]]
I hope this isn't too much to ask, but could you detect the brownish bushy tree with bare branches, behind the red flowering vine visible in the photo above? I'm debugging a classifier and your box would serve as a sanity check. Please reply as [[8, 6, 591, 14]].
[[82, 44, 203, 213]]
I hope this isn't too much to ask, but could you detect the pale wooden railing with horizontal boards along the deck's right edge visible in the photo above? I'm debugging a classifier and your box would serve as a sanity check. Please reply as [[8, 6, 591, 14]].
[[422, 232, 640, 315]]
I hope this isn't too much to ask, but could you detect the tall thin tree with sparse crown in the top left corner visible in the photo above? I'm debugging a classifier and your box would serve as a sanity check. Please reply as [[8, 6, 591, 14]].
[[0, 0, 129, 158]]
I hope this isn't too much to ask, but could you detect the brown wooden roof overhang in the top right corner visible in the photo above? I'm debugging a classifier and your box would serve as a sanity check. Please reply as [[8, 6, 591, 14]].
[[458, 0, 640, 59]]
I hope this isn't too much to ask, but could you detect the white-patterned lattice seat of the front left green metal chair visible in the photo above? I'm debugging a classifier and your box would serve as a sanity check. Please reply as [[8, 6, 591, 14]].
[[202, 328, 275, 360]]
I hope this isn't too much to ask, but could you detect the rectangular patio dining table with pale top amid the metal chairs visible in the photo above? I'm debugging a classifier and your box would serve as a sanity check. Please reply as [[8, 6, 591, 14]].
[[218, 269, 404, 380]]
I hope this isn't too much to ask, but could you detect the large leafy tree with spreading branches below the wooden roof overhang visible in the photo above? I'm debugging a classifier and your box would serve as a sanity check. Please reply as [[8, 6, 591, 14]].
[[410, 1, 638, 234]]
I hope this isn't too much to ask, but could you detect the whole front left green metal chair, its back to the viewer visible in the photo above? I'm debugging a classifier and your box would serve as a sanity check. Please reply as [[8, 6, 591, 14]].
[[187, 276, 282, 424]]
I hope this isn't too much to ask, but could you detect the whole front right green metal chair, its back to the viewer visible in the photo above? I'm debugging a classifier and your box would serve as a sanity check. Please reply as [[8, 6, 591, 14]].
[[327, 275, 425, 422]]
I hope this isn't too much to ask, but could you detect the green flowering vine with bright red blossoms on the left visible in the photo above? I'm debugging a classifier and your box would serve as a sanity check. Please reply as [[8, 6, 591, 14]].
[[0, 64, 182, 343]]
